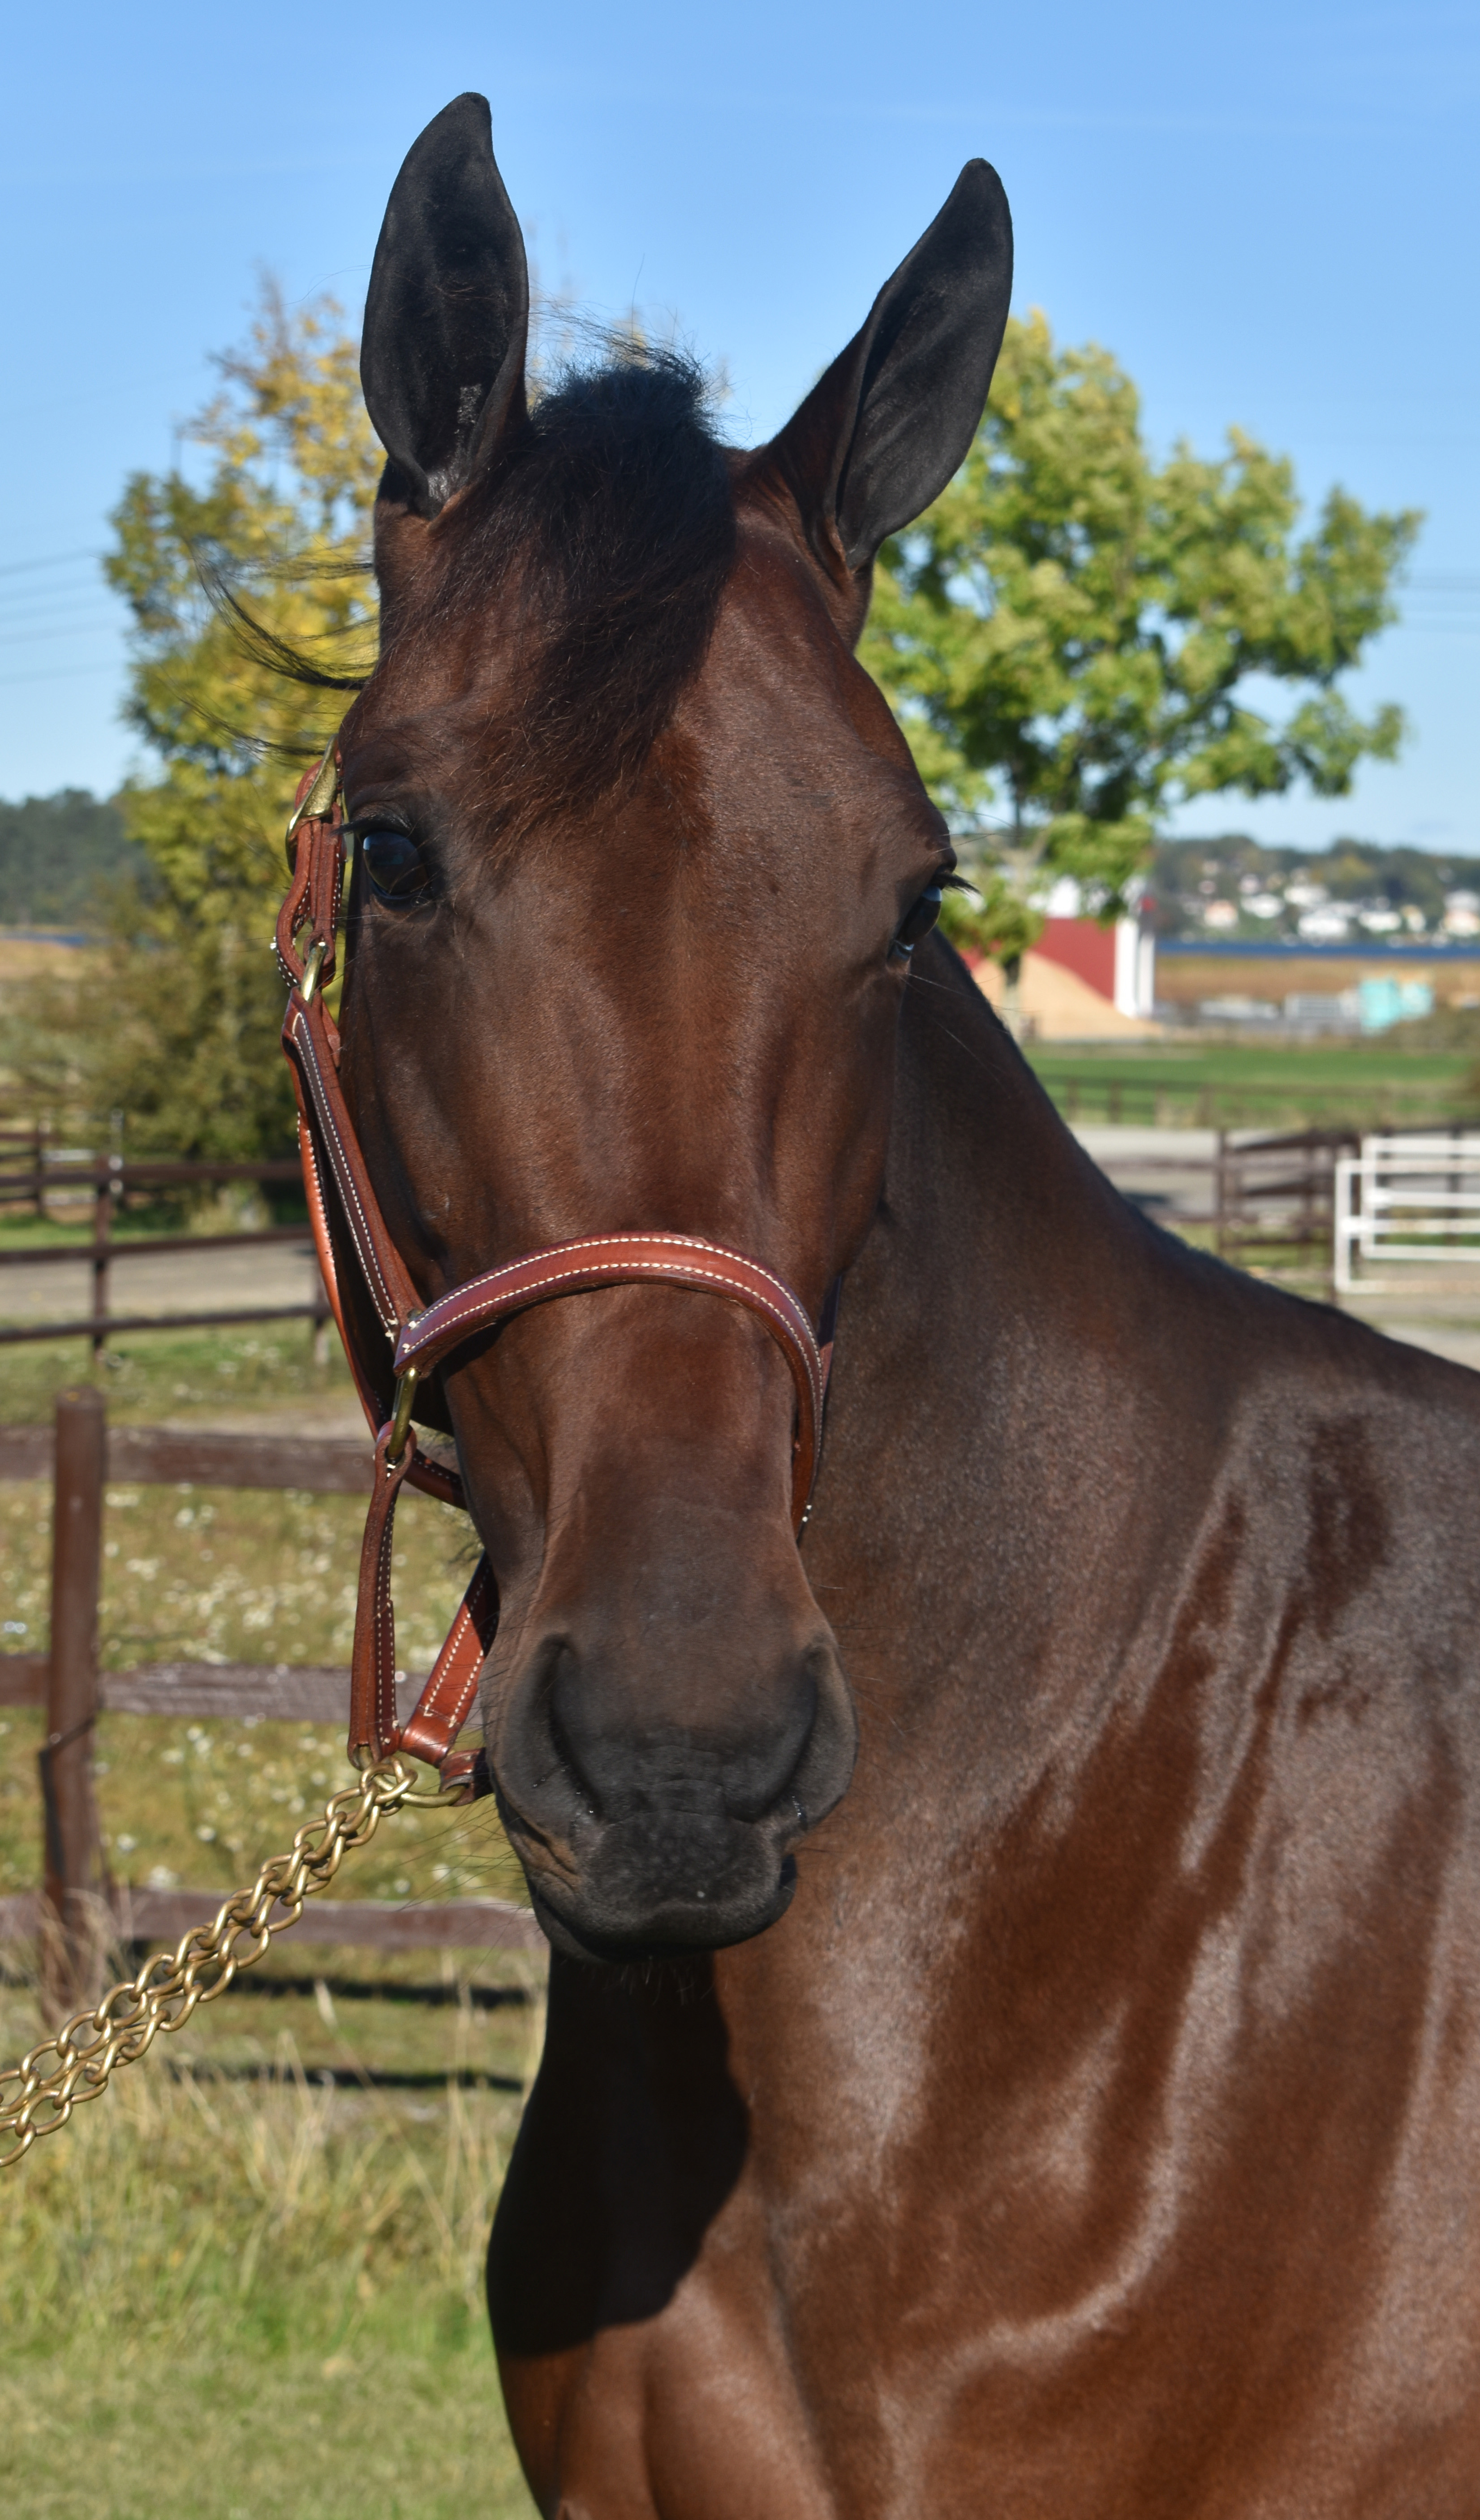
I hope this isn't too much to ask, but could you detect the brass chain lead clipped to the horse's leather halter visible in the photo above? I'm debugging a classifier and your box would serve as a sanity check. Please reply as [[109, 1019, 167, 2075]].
[[0, 1759, 443, 2170]]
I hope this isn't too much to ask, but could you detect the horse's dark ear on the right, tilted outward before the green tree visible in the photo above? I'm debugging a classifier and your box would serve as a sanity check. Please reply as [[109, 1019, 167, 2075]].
[[766, 159, 1014, 572]]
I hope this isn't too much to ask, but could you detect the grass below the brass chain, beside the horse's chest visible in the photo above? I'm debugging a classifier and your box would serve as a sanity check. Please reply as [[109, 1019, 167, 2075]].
[[0, 1981, 537, 2520]]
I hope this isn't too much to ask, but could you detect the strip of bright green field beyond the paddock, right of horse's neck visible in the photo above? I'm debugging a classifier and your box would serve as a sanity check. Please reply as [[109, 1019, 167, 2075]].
[[1026, 1038, 1480, 1131]]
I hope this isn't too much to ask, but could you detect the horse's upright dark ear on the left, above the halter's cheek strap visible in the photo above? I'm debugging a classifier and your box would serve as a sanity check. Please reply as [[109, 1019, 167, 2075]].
[[361, 96, 529, 517]]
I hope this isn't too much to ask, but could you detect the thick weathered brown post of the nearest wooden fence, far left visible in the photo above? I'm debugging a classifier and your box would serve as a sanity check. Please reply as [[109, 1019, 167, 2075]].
[[40, 1391, 106, 2011]]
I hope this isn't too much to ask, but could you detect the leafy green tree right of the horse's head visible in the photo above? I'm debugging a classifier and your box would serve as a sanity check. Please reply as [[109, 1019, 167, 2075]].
[[860, 315, 1420, 960]]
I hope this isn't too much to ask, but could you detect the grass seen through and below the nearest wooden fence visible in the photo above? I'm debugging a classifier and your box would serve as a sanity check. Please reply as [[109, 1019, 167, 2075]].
[[0, 1325, 542, 2520]]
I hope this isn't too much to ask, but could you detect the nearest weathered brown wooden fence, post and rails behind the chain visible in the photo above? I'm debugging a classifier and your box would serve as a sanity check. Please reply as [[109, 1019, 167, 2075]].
[[0, 1391, 545, 2008]]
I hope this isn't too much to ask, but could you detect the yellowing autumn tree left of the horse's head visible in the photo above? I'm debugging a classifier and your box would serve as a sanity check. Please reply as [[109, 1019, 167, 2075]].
[[8, 285, 383, 1159]]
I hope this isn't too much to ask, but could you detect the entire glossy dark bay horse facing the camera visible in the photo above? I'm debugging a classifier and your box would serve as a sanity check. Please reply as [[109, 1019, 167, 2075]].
[[343, 96, 1480, 2520]]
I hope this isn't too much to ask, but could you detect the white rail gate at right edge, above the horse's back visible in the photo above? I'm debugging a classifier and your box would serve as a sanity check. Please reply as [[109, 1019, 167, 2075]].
[[1334, 1129, 1480, 1295]]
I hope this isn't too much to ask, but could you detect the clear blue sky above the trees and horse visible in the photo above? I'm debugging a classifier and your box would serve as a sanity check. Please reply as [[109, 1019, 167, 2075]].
[[0, 0, 1480, 854]]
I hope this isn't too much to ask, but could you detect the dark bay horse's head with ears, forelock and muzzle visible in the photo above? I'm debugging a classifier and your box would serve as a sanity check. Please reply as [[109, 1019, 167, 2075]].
[[332, 96, 1011, 1958]]
